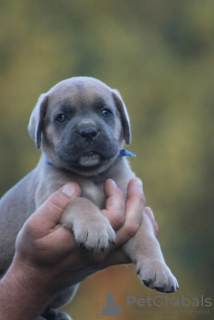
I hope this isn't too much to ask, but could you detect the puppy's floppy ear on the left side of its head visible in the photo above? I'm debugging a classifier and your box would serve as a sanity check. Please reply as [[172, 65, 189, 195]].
[[28, 94, 48, 149]]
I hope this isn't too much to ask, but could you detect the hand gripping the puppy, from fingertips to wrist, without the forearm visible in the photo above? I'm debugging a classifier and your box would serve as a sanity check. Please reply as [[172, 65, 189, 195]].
[[10, 178, 156, 297]]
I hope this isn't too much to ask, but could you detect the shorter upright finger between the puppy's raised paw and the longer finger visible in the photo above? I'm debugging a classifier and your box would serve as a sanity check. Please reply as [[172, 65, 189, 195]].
[[102, 179, 125, 230]]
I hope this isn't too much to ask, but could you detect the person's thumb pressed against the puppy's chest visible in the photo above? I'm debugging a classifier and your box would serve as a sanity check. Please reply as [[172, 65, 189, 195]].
[[26, 182, 81, 233]]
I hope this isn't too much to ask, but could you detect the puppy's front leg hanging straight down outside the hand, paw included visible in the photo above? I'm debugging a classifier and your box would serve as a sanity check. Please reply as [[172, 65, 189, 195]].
[[124, 213, 178, 292]]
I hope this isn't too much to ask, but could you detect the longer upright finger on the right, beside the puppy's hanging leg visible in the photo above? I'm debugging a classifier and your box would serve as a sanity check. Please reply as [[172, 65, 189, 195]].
[[116, 178, 145, 245]]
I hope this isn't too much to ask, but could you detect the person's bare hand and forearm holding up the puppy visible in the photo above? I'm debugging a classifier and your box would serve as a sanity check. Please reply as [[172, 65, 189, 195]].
[[0, 178, 157, 320]]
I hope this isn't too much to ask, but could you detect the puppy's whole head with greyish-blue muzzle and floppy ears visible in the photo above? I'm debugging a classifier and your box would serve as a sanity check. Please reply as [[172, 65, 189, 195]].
[[28, 77, 131, 175]]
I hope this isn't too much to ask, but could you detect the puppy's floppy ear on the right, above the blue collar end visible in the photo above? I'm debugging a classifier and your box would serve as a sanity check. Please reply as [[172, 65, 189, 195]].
[[112, 89, 131, 144]]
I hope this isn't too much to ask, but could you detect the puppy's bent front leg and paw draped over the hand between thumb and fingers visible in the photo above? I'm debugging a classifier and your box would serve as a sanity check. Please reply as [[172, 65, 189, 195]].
[[61, 198, 116, 251]]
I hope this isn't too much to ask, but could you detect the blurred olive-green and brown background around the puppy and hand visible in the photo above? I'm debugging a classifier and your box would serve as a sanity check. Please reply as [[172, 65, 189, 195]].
[[0, 0, 214, 320]]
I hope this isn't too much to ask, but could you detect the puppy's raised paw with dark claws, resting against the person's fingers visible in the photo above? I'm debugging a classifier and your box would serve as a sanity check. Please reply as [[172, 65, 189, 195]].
[[73, 214, 116, 251]]
